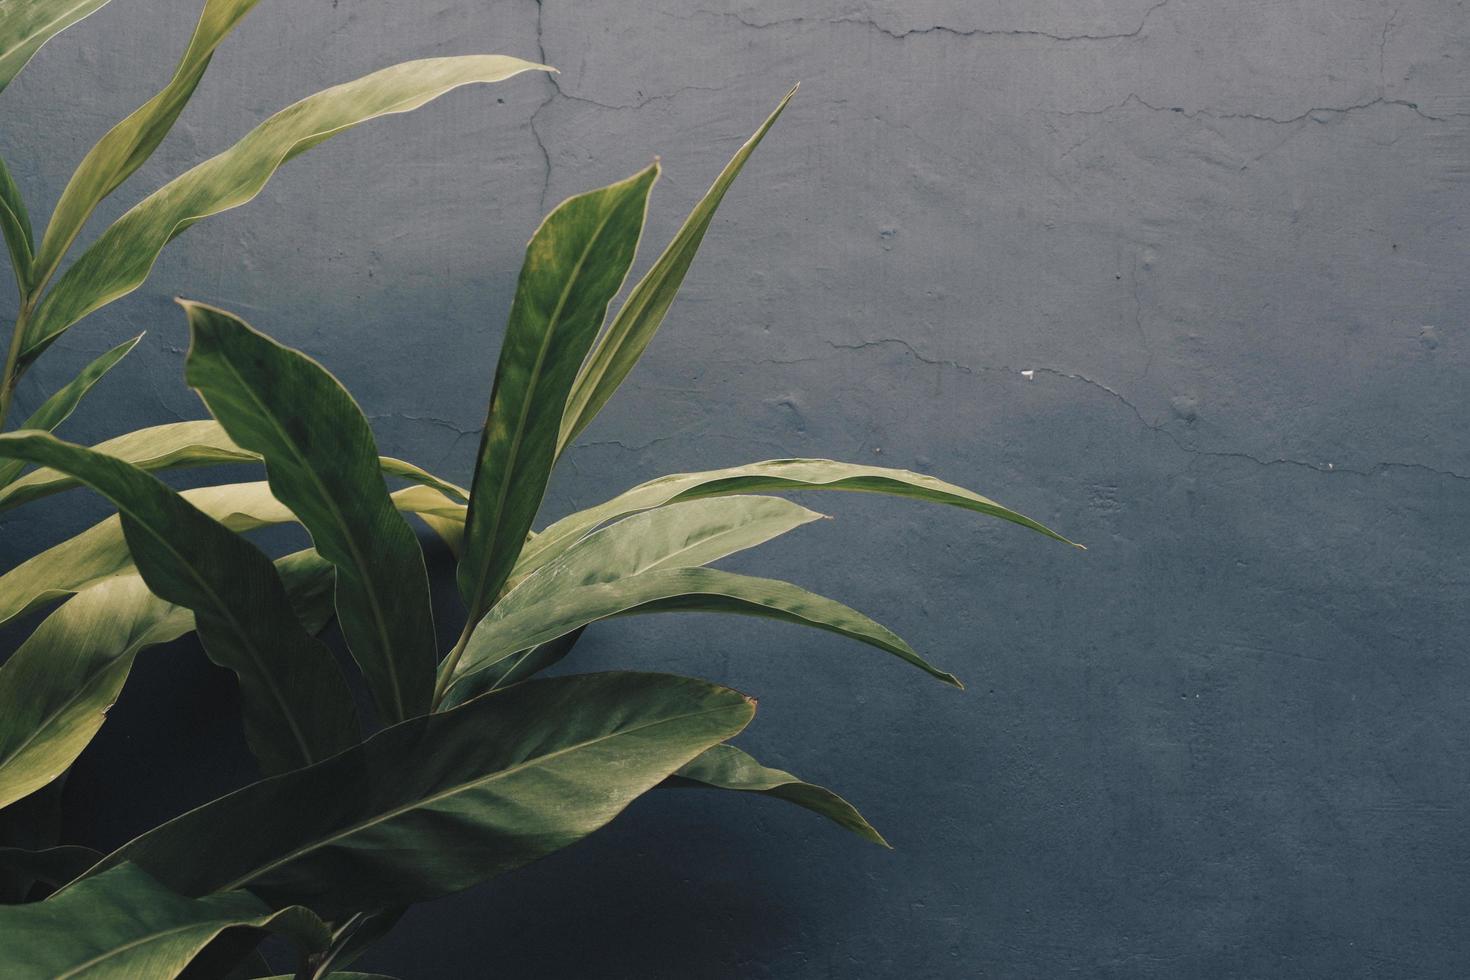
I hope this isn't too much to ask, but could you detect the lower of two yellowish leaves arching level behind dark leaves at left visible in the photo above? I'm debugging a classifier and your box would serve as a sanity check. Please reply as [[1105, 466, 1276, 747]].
[[0, 482, 465, 624]]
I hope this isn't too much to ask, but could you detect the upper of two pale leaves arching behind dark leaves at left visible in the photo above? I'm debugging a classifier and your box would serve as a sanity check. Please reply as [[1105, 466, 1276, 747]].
[[0, 419, 469, 523]]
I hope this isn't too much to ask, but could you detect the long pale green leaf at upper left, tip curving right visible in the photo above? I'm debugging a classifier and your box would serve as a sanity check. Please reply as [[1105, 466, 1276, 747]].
[[22, 54, 550, 359]]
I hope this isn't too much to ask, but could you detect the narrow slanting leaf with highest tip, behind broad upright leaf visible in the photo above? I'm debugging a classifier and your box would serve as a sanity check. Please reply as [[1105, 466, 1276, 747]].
[[557, 85, 798, 454]]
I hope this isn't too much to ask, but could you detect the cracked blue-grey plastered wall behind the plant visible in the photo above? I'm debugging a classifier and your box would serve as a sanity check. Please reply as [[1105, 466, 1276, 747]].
[[0, 0, 1470, 979]]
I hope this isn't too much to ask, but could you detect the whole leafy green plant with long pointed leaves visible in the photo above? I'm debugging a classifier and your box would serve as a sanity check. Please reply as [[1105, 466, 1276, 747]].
[[0, 0, 1064, 977]]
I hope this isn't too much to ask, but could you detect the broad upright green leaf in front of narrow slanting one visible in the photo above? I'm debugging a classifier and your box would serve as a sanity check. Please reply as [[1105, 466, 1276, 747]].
[[451, 163, 659, 628]]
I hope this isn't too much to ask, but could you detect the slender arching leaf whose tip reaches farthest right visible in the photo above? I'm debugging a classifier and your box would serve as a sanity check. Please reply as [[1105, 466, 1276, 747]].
[[513, 460, 1080, 580]]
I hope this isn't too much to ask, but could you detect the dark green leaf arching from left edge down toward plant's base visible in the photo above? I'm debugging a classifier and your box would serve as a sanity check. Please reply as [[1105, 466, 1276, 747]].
[[0, 432, 357, 771]]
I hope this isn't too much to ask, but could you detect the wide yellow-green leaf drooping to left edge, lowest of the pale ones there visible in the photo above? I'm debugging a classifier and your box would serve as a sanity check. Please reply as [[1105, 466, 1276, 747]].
[[0, 551, 332, 807]]
